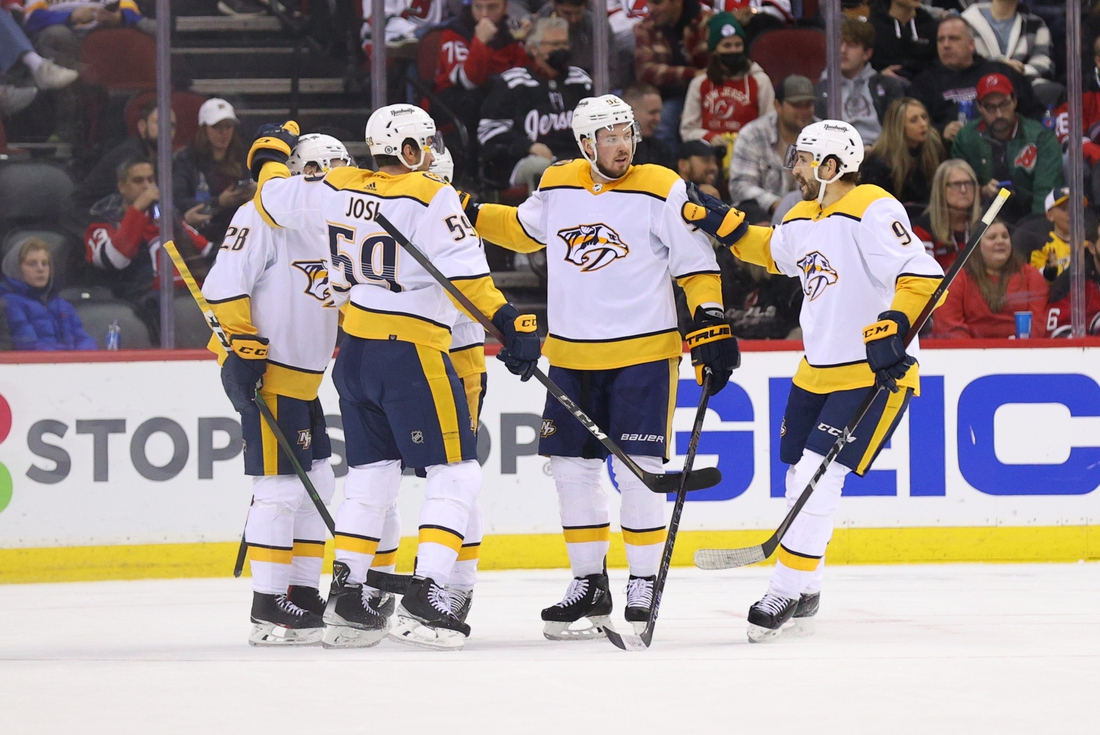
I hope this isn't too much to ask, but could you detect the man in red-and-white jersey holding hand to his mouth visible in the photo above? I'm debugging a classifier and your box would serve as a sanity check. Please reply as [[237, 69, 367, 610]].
[[84, 158, 213, 336]]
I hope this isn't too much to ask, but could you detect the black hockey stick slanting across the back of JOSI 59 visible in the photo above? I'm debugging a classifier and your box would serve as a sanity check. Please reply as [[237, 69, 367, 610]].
[[374, 212, 722, 494]]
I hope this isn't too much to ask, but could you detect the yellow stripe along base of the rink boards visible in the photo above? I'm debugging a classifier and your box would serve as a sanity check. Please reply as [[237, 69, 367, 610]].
[[0, 526, 1100, 584]]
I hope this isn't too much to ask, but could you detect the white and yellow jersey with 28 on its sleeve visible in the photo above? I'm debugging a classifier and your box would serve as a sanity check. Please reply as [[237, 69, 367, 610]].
[[202, 201, 339, 401]]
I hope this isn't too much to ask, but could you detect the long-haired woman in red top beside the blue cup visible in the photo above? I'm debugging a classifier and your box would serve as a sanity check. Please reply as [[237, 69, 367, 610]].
[[933, 219, 1051, 339]]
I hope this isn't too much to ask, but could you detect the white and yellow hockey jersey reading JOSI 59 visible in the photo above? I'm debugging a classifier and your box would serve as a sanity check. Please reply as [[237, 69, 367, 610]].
[[256, 165, 505, 352]]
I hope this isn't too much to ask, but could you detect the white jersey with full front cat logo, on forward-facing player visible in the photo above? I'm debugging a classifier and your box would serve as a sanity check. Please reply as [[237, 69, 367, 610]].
[[477, 158, 722, 370]]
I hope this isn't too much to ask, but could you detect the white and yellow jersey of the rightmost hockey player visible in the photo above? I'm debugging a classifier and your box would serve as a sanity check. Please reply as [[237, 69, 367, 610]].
[[733, 186, 944, 393]]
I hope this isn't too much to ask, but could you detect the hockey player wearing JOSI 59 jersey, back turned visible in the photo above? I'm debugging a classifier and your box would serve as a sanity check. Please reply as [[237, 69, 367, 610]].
[[249, 105, 540, 649]]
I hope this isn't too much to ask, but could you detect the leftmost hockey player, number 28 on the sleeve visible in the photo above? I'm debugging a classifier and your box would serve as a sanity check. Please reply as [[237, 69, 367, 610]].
[[202, 135, 351, 645]]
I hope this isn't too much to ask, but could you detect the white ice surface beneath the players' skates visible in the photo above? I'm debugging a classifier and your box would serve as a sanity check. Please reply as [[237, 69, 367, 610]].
[[0, 563, 1100, 735]]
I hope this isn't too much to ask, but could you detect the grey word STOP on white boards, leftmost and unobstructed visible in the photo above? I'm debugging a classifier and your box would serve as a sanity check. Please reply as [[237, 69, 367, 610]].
[[26, 416, 244, 485]]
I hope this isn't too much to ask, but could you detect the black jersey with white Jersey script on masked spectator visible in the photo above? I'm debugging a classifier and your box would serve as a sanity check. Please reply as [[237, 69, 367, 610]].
[[477, 66, 592, 178]]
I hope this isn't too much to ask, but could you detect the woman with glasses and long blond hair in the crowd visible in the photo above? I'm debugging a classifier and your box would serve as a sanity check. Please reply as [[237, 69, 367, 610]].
[[913, 158, 980, 271]]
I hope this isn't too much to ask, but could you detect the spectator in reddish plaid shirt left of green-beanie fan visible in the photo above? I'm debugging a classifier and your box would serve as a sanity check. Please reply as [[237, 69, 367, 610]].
[[634, 0, 712, 149]]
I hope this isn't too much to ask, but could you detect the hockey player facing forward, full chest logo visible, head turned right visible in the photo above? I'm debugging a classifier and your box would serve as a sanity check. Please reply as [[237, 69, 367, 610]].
[[468, 95, 739, 639]]
